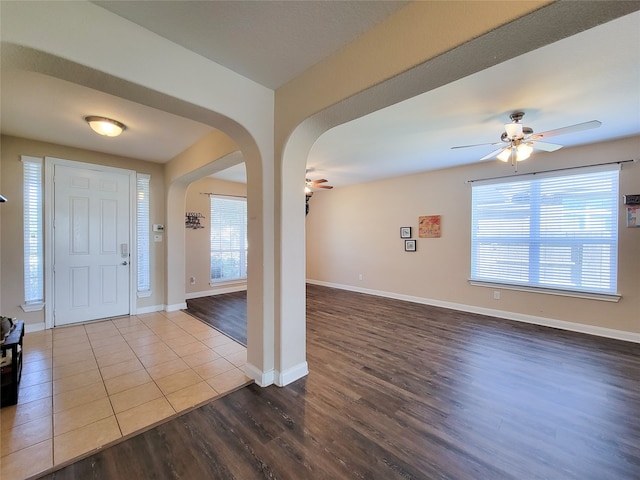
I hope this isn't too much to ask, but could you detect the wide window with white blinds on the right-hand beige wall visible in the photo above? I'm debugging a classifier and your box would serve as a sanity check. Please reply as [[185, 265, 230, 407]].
[[471, 165, 619, 294]]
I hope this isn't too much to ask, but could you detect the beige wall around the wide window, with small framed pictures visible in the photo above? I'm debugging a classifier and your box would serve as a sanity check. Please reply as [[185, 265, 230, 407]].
[[306, 137, 640, 341]]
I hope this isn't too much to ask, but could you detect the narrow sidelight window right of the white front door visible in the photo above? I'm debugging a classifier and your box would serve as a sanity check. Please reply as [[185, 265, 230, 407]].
[[136, 174, 151, 296]]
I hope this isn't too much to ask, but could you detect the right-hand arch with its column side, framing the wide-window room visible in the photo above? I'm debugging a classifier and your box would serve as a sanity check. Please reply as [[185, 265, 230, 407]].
[[275, 2, 627, 385]]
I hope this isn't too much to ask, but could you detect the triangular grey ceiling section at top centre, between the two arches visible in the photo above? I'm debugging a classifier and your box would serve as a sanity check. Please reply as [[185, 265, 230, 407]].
[[93, 0, 408, 89]]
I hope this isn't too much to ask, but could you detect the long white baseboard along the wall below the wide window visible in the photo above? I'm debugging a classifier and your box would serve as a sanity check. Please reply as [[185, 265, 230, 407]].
[[307, 279, 640, 343]]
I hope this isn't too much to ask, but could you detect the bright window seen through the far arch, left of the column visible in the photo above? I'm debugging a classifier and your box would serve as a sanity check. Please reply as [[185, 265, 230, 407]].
[[211, 195, 247, 283]]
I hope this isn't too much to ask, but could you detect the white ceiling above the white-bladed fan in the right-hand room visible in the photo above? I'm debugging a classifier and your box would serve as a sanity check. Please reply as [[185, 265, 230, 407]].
[[308, 12, 640, 185]]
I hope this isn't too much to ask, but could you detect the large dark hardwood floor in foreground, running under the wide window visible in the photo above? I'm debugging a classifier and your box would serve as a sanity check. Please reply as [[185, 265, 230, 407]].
[[36, 285, 640, 480]]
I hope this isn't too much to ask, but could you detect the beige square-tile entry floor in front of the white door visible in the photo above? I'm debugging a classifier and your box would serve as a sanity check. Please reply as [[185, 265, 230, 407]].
[[0, 312, 249, 480]]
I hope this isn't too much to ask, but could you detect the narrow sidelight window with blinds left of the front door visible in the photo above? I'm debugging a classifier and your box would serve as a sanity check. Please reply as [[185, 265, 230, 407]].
[[22, 156, 44, 305]]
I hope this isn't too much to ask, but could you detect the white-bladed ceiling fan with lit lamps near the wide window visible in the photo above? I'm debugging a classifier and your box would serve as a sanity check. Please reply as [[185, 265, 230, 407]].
[[451, 112, 602, 166]]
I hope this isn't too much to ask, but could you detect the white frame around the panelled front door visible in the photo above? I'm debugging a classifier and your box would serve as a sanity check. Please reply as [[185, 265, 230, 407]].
[[44, 157, 138, 328]]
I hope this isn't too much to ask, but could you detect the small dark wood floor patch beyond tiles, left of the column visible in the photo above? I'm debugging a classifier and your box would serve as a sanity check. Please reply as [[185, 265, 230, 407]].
[[186, 291, 247, 347]]
